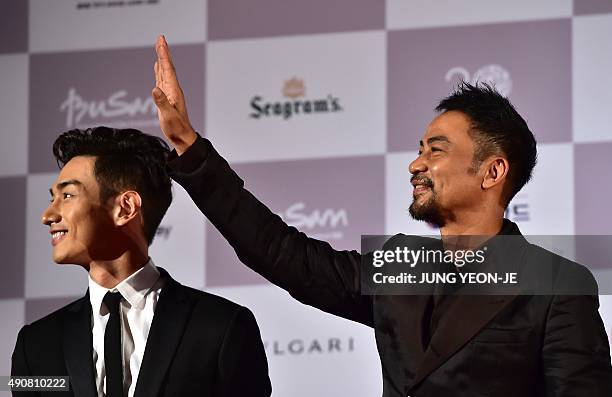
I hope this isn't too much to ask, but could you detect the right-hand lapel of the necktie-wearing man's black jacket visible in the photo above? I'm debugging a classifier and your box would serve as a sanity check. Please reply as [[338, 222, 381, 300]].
[[134, 267, 192, 397]]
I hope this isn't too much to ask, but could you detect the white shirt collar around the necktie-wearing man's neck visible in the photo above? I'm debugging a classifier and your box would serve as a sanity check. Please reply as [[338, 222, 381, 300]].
[[89, 258, 159, 314]]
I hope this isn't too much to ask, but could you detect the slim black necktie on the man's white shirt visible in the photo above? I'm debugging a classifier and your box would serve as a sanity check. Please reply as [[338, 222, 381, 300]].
[[103, 291, 123, 397]]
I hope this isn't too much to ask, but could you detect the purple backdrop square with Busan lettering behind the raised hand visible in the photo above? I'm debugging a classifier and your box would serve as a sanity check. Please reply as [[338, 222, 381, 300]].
[[29, 44, 204, 172]]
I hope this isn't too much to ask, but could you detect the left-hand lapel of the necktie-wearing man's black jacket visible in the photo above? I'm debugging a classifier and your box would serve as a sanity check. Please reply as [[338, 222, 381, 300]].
[[63, 292, 97, 397]]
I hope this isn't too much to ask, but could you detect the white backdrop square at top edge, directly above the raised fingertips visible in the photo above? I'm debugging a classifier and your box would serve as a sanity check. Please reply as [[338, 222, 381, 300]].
[[28, 0, 207, 53]]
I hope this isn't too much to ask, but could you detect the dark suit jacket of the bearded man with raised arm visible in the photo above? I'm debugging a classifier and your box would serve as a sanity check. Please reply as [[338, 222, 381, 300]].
[[169, 138, 612, 397]]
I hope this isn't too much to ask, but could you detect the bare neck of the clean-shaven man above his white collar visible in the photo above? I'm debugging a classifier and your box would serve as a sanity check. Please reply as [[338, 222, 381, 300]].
[[89, 250, 149, 289]]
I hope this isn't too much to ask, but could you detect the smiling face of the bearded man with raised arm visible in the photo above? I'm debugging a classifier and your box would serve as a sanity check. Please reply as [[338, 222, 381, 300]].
[[410, 111, 482, 227]]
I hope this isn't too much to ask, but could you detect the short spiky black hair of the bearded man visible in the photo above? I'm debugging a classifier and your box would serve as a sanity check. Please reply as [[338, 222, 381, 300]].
[[436, 81, 537, 205]]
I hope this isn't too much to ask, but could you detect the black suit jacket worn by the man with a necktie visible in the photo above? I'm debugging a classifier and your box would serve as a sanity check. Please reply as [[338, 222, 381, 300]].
[[11, 268, 271, 397]]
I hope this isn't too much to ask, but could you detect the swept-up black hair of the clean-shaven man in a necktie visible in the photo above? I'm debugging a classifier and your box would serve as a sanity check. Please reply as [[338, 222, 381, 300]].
[[53, 126, 172, 245]]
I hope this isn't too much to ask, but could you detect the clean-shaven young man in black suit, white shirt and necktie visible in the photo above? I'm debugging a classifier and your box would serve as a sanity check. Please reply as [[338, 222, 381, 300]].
[[11, 127, 271, 397]]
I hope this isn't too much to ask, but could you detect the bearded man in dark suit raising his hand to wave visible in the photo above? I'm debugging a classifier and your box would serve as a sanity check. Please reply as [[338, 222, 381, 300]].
[[153, 37, 612, 397]]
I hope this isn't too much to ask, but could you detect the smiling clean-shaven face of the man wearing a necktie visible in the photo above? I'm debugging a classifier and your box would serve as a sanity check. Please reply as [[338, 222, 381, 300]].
[[41, 156, 114, 266]]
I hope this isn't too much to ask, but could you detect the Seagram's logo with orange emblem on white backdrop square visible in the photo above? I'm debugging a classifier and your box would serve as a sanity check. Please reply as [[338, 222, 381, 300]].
[[249, 77, 343, 120]]
